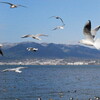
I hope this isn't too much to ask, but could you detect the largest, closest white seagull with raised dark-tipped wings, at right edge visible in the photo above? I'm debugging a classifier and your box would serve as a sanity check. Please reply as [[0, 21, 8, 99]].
[[79, 20, 100, 49]]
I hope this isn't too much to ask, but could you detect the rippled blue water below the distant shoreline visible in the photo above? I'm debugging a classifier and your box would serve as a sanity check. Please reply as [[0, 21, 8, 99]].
[[0, 65, 100, 100]]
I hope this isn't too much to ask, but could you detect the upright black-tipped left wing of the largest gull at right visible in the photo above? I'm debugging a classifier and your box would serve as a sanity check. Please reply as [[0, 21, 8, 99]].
[[83, 20, 93, 41]]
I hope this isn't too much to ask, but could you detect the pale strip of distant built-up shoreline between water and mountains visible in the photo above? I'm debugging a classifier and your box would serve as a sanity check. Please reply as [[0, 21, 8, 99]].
[[0, 59, 100, 65]]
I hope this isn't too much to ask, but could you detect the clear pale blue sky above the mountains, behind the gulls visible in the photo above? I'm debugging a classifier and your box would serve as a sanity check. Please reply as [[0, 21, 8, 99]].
[[0, 0, 100, 44]]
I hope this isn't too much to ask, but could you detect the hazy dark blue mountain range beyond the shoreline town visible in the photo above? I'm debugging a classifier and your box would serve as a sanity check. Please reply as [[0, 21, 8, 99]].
[[0, 42, 100, 61]]
